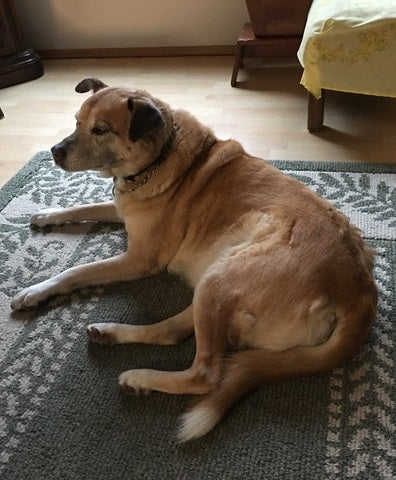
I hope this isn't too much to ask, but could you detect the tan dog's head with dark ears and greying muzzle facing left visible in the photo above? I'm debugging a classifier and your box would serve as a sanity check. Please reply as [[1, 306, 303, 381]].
[[51, 78, 172, 175]]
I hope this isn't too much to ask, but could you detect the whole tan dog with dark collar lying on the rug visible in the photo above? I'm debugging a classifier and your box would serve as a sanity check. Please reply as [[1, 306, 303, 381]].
[[12, 79, 377, 441]]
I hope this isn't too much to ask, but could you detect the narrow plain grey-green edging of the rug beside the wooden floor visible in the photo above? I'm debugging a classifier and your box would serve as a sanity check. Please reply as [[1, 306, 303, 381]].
[[0, 150, 396, 209]]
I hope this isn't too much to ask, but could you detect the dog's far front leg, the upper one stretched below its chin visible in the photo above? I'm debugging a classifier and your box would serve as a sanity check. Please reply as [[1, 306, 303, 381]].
[[30, 202, 122, 227]]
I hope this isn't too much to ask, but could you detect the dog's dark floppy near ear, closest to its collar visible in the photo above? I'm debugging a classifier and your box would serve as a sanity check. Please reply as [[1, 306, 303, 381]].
[[128, 98, 165, 142]]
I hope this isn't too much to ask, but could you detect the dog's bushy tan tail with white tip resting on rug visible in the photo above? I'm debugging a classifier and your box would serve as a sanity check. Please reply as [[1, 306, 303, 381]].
[[178, 287, 376, 442]]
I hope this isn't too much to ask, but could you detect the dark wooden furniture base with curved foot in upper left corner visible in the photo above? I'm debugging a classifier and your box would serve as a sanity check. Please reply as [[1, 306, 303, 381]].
[[0, 0, 44, 88]]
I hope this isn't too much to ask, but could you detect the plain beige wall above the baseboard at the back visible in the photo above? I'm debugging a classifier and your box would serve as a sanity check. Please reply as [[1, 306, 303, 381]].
[[14, 0, 248, 50]]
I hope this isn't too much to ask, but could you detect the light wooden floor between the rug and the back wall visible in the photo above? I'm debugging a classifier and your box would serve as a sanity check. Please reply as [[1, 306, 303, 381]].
[[0, 56, 396, 185]]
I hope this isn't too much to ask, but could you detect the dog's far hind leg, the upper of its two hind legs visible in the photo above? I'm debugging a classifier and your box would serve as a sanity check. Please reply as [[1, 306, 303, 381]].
[[87, 305, 194, 345]]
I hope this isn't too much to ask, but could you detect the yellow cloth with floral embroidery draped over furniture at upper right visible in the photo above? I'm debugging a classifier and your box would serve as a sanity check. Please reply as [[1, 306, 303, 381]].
[[296, 0, 396, 98]]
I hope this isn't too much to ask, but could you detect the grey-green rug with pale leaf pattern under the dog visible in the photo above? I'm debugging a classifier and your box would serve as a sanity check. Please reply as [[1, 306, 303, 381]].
[[0, 152, 396, 480]]
